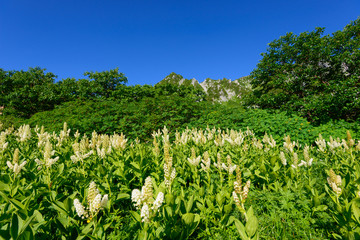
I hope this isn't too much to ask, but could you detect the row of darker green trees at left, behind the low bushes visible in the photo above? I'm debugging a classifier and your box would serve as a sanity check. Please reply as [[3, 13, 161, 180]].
[[0, 67, 204, 118]]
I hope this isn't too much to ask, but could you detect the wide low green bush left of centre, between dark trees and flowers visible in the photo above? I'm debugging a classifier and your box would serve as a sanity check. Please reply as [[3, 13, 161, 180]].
[[27, 96, 202, 140]]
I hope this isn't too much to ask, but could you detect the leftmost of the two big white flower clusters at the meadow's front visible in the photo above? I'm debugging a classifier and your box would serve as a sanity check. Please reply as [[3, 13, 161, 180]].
[[74, 182, 108, 221]]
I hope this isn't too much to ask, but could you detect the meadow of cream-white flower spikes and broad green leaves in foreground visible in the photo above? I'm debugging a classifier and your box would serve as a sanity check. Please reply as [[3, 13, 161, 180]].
[[0, 123, 360, 239]]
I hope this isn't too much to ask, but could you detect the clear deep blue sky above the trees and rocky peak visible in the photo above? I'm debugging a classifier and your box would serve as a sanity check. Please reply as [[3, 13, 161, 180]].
[[0, 0, 360, 85]]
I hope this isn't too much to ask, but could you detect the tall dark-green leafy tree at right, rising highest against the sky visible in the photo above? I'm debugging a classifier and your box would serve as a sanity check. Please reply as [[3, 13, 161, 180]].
[[247, 18, 360, 122]]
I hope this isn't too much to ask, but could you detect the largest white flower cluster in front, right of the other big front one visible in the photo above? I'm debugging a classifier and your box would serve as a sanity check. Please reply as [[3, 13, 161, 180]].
[[131, 177, 164, 222]]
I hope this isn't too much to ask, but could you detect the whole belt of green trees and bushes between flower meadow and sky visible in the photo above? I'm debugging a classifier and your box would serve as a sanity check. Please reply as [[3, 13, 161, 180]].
[[0, 19, 360, 143]]
